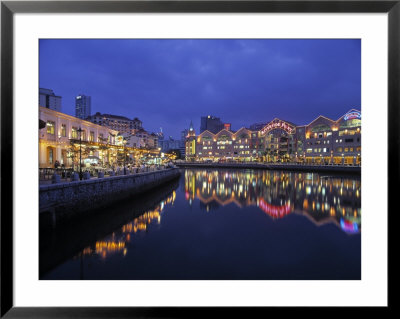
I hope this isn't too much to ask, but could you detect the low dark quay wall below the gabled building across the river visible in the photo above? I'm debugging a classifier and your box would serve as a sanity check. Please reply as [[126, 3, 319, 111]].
[[175, 161, 361, 175]]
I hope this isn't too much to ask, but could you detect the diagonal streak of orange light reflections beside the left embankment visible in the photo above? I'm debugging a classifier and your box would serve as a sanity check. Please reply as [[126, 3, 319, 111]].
[[76, 191, 176, 259]]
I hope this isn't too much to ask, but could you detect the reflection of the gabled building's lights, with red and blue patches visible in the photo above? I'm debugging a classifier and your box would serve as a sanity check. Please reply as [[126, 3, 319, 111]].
[[185, 170, 361, 233]]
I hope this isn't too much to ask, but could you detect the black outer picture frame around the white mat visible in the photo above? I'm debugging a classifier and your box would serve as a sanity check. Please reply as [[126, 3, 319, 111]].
[[0, 0, 394, 318]]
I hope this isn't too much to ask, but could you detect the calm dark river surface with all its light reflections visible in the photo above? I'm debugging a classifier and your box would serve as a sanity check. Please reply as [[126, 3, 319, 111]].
[[39, 169, 361, 280]]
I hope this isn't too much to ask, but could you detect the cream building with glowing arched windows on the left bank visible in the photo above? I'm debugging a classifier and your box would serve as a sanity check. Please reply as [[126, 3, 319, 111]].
[[39, 107, 118, 168]]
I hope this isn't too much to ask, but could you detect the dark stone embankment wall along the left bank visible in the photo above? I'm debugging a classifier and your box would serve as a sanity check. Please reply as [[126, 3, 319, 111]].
[[39, 167, 180, 224]]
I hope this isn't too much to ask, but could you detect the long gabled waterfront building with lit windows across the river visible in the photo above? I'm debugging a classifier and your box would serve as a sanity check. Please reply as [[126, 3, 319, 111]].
[[186, 109, 361, 165]]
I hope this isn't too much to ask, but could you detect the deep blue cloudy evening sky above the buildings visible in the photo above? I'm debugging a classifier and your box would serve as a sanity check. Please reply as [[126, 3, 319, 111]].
[[39, 40, 361, 138]]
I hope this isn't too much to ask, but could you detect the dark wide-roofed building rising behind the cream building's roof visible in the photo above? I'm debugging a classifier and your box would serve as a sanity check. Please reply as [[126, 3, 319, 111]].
[[86, 112, 142, 133]]
